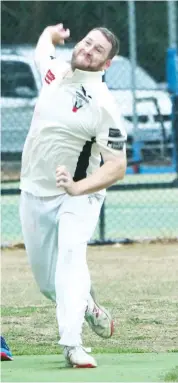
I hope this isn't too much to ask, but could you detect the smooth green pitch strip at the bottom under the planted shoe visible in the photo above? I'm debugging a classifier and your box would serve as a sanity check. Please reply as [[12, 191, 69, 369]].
[[2, 353, 178, 382]]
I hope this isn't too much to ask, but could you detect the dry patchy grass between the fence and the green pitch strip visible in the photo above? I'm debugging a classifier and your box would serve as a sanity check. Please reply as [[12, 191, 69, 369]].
[[1, 243, 178, 355]]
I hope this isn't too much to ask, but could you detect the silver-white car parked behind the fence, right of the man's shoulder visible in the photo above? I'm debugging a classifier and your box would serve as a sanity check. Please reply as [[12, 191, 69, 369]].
[[105, 56, 172, 160]]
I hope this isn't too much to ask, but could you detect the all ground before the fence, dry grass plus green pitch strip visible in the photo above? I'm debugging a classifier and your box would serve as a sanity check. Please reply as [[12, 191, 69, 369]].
[[1, 243, 178, 382]]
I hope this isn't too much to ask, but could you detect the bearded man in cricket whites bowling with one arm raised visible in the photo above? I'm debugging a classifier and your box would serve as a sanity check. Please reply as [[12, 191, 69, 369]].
[[20, 24, 126, 367]]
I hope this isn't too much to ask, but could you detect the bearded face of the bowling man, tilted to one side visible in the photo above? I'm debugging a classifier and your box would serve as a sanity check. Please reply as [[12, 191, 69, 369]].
[[71, 30, 112, 72]]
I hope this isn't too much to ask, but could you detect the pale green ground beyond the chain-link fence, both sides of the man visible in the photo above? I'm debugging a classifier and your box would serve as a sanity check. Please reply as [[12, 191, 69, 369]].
[[1, 175, 178, 244]]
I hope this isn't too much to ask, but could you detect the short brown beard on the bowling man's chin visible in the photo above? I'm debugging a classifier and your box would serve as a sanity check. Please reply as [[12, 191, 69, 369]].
[[71, 51, 104, 72]]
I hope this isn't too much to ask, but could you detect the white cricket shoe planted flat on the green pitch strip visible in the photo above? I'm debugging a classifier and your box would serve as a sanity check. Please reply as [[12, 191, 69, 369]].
[[64, 346, 97, 368]]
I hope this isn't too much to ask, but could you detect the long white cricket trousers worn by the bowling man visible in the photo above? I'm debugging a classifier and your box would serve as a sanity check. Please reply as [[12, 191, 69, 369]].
[[20, 191, 104, 346]]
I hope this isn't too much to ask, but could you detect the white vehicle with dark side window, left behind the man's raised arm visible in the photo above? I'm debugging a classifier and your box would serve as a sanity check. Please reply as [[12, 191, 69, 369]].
[[1, 47, 70, 159]]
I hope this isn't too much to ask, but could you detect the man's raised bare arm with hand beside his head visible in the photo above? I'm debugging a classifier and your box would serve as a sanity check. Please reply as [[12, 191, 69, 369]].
[[35, 24, 70, 78]]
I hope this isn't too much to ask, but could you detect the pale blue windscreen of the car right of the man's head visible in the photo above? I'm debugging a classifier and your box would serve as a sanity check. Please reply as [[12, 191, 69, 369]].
[[104, 58, 157, 90]]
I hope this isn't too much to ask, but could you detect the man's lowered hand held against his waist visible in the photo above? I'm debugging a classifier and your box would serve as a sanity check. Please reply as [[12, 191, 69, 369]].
[[56, 166, 78, 196]]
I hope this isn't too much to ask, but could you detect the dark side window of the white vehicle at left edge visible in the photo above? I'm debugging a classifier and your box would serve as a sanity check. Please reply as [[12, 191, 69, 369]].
[[1, 60, 37, 97]]
